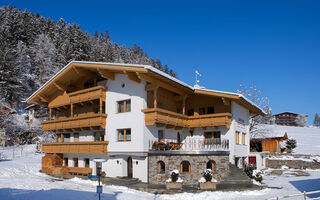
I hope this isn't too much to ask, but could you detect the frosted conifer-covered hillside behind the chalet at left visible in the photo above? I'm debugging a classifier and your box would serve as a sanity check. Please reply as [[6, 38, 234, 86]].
[[0, 6, 176, 112]]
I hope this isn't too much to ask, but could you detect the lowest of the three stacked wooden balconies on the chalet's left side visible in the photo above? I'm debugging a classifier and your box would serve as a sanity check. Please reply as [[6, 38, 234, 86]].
[[42, 141, 109, 154]]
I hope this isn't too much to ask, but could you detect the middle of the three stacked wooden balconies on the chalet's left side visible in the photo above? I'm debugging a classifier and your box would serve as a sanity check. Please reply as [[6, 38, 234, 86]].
[[41, 113, 107, 131]]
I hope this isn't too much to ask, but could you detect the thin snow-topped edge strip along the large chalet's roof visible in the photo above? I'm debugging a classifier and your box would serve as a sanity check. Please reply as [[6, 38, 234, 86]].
[[25, 61, 265, 114]]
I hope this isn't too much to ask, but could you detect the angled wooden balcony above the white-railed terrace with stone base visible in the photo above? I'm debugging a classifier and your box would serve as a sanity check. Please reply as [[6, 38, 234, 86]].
[[142, 108, 232, 129]]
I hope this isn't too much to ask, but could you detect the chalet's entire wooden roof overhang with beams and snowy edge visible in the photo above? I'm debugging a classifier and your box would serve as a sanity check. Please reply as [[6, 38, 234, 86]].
[[26, 61, 265, 115]]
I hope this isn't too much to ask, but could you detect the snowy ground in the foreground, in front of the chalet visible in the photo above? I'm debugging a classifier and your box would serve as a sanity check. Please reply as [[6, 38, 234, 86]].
[[0, 145, 320, 200]]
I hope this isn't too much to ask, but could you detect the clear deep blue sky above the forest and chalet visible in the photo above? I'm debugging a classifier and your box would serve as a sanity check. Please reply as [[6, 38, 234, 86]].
[[0, 0, 320, 123]]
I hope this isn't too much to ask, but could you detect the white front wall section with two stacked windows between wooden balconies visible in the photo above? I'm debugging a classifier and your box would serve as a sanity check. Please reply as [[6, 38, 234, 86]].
[[105, 74, 147, 152]]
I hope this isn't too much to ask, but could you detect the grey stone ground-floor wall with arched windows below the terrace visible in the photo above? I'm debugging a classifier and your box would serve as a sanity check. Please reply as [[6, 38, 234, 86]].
[[148, 154, 229, 185]]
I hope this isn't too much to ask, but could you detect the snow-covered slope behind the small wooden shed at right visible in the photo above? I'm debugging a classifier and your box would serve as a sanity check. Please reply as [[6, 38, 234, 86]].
[[268, 125, 320, 155]]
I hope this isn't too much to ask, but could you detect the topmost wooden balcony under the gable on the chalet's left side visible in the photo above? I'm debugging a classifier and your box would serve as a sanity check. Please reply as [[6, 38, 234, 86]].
[[49, 86, 107, 108]]
